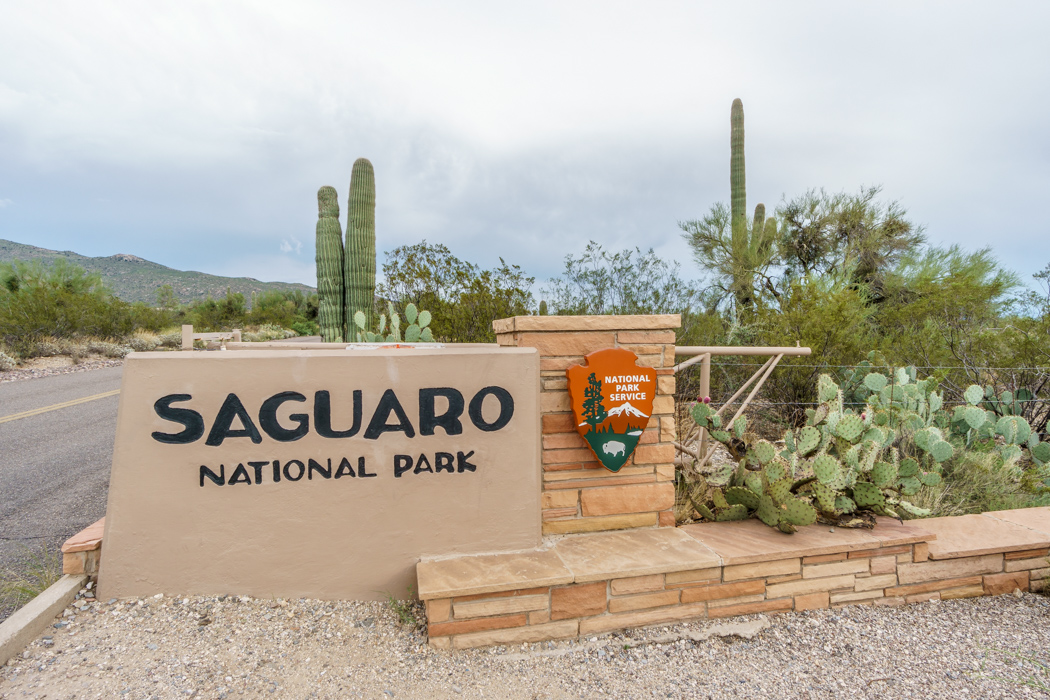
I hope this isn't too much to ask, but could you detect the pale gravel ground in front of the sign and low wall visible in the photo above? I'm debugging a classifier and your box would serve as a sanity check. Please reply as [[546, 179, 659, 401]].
[[0, 591, 1050, 699]]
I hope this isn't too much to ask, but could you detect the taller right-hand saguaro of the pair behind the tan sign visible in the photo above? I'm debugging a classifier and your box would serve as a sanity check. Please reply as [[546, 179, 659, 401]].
[[343, 158, 376, 333]]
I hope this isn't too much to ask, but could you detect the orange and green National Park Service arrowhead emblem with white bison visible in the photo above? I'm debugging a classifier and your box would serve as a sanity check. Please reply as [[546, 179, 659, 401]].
[[565, 347, 656, 471]]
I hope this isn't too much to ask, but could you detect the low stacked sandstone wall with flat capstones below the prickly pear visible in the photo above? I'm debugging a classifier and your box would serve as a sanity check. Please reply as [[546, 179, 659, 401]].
[[417, 508, 1050, 649]]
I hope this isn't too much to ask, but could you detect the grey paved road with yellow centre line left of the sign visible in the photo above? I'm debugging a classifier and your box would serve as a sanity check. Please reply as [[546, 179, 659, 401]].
[[0, 367, 123, 620]]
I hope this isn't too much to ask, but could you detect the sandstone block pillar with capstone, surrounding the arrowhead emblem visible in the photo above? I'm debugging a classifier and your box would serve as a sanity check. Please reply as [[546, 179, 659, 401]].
[[492, 315, 681, 534]]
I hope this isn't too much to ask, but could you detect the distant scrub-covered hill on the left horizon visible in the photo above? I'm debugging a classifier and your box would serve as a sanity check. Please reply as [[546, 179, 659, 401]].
[[0, 238, 316, 304]]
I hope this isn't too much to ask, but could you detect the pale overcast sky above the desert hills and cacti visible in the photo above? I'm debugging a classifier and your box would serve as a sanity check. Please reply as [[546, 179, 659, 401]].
[[0, 0, 1050, 284]]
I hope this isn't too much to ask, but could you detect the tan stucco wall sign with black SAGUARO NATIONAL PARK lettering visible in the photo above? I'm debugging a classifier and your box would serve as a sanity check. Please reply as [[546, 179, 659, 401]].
[[99, 347, 540, 599]]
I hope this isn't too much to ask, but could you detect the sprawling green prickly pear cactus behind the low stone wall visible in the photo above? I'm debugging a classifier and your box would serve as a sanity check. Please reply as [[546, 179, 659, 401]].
[[692, 365, 1050, 533]]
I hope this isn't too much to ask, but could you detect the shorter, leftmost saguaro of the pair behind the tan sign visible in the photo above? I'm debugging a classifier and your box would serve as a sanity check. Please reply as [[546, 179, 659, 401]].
[[315, 185, 349, 342]]
